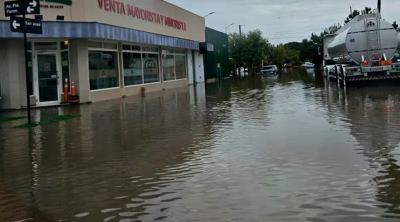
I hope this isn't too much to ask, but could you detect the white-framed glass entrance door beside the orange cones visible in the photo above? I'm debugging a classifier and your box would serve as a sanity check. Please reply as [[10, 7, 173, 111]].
[[35, 53, 61, 104]]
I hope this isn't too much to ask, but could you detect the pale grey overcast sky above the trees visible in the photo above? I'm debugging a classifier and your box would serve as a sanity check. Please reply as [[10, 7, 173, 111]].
[[167, 0, 400, 44]]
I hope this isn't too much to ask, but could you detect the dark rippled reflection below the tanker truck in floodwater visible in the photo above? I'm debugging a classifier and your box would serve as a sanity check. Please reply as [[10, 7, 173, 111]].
[[324, 87, 400, 218]]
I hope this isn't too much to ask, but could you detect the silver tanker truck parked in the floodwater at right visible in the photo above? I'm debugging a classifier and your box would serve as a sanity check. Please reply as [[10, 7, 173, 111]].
[[323, 10, 400, 86]]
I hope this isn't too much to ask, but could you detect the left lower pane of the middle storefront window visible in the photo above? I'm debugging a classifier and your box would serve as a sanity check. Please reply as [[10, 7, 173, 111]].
[[123, 52, 143, 86]]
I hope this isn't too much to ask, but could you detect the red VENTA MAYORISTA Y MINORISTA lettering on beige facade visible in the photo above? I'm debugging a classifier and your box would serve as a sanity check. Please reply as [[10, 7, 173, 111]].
[[97, 0, 186, 31]]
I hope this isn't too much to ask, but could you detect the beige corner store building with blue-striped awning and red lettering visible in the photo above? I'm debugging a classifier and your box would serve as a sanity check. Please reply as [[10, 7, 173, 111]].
[[0, 0, 205, 109]]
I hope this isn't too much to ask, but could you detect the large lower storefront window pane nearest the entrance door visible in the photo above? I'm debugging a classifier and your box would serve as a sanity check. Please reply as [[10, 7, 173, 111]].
[[88, 51, 119, 90]]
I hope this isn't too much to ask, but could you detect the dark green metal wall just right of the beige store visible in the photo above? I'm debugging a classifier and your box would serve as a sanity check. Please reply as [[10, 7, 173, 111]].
[[204, 28, 230, 79]]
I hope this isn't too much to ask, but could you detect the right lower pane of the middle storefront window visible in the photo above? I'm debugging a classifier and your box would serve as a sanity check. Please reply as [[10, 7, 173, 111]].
[[143, 53, 160, 83]]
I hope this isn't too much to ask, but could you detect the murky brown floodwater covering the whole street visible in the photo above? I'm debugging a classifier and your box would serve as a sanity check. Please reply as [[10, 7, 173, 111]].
[[0, 70, 400, 222]]
